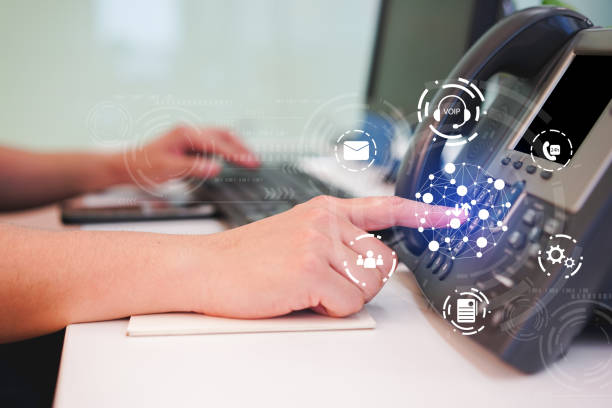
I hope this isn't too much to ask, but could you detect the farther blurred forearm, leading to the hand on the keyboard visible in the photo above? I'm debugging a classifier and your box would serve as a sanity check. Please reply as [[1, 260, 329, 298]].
[[0, 148, 129, 210]]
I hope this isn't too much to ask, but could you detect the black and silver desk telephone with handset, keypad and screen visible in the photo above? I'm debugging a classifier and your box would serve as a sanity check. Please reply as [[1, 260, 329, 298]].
[[391, 7, 612, 373]]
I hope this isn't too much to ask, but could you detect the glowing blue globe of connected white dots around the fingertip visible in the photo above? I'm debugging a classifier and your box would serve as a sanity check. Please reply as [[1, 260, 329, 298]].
[[414, 163, 512, 259]]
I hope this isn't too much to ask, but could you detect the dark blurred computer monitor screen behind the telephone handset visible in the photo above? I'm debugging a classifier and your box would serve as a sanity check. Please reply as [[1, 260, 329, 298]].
[[366, 0, 502, 113]]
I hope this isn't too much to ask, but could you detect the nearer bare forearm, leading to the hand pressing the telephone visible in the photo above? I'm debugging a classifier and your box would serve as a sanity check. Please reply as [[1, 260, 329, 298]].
[[0, 225, 206, 342]]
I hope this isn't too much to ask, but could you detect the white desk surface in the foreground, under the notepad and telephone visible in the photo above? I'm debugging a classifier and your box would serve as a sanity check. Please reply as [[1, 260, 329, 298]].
[[55, 220, 612, 408]]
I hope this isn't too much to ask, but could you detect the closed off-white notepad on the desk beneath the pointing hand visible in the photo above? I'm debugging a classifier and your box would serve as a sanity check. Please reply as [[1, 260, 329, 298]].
[[127, 308, 376, 336]]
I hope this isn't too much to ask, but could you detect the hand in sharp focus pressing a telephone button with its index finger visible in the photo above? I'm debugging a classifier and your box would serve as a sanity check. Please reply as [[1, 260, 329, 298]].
[[191, 196, 464, 318]]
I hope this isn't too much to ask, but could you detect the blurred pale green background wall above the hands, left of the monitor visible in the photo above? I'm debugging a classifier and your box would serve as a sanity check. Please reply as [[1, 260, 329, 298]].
[[0, 0, 612, 150]]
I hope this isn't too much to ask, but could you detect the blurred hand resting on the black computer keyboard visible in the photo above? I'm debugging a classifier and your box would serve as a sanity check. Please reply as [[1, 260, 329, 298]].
[[115, 126, 259, 183]]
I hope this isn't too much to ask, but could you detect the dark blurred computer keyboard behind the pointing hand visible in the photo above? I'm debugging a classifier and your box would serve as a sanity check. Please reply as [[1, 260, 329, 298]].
[[194, 163, 351, 226]]
